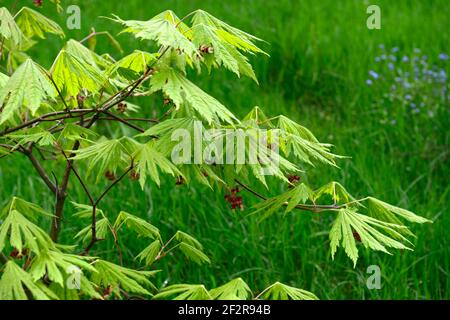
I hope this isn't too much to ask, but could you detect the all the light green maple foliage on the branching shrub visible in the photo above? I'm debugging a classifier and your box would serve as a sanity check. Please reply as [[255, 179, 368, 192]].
[[0, 7, 429, 300]]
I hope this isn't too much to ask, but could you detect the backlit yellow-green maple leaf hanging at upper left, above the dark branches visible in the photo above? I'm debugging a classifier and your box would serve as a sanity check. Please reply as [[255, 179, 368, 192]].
[[50, 50, 106, 98]]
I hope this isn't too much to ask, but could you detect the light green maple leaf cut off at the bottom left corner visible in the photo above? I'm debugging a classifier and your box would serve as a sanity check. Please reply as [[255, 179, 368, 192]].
[[0, 261, 58, 300]]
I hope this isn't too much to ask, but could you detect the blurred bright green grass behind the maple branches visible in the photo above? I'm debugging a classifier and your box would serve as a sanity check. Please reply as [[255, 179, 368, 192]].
[[0, 0, 450, 299]]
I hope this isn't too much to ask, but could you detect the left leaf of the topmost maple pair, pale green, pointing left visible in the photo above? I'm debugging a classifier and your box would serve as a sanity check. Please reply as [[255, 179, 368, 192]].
[[114, 10, 200, 57]]
